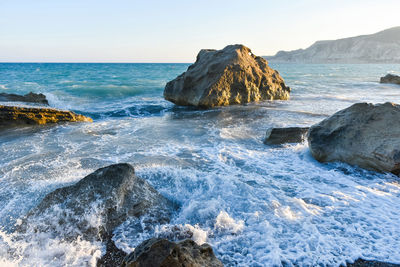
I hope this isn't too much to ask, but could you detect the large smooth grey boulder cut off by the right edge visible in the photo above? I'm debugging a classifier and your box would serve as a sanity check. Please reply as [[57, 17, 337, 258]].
[[308, 103, 400, 174]]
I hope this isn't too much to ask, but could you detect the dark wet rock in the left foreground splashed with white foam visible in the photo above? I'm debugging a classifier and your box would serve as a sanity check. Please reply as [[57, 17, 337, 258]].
[[24, 164, 176, 241]]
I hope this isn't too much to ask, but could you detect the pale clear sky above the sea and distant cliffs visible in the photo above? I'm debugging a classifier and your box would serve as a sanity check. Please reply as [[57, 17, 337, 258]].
[[0, 0, 400, 63]]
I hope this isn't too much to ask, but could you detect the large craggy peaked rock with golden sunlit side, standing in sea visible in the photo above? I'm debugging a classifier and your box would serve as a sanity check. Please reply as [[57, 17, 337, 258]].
[[164, 45, 290, 108]]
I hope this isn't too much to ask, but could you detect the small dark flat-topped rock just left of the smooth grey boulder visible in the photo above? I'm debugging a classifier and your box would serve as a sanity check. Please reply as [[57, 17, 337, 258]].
[[264, 127, 309, 145]]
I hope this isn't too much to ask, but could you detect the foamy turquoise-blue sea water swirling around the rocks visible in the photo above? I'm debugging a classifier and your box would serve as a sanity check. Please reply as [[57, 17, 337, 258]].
[[0, 63, 400, 266]]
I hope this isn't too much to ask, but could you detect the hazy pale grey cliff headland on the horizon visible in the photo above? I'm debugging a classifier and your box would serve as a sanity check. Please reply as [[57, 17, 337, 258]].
[[264, 27, 400, 63]]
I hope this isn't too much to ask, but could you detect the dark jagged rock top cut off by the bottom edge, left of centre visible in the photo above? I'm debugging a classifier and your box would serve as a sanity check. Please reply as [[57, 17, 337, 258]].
[[121, 238, 223, 267]]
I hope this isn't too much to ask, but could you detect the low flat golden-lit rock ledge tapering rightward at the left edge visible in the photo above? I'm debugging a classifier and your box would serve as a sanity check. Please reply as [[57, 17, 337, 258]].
[[0, 105, 92, 128]]
